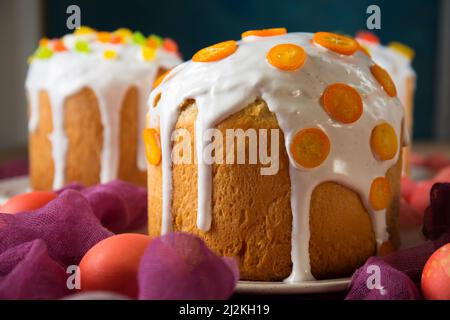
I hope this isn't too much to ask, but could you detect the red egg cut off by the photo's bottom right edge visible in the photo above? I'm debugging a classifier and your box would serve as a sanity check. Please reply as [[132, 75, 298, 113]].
[[422, 243, 450, 300]]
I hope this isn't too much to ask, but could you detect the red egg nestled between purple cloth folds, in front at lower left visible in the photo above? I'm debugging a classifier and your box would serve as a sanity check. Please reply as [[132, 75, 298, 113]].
[[80, 233, 151, 298]]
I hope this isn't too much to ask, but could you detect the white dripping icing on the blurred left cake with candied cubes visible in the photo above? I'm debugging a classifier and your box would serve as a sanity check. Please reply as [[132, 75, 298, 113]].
[[25, 34, 181, 189]]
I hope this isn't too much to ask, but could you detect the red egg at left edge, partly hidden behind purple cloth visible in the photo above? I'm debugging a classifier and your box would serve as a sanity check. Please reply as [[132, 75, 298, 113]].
[[0, 191, 58, 213]]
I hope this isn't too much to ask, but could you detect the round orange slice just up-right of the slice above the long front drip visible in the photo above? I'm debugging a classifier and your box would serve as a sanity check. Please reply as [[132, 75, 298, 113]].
[[323, 83, 363, 123]]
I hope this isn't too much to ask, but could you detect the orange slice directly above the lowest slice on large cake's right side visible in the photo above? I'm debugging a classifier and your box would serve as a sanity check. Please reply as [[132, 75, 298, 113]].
[[370, 123, 398, 161]]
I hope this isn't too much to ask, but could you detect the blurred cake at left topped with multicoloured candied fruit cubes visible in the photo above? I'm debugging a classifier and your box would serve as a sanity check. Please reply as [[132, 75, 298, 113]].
[[26, 27, 181, 190]]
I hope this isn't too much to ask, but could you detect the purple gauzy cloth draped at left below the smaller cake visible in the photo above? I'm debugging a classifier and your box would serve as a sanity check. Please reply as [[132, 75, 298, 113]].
[[0, 181, 147, 299]]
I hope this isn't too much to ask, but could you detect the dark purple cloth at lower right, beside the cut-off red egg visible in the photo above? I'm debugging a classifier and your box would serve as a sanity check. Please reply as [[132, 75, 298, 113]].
[[346, 183, 450, 300]]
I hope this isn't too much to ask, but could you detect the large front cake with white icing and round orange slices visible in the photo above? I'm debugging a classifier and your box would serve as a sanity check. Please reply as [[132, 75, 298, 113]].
[[144, 28, 407, 281]]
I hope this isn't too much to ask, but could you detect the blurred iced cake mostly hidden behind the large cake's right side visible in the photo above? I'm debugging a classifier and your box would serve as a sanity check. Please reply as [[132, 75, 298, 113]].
[[356, 31, 416, 175]]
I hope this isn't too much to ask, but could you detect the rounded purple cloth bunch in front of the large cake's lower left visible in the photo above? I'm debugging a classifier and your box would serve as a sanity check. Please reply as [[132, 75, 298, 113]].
[[138, 233, 239, 300]]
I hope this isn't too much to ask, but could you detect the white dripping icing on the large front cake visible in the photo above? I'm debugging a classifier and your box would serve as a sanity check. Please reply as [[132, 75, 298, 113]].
[[148, 33, 403, 281]]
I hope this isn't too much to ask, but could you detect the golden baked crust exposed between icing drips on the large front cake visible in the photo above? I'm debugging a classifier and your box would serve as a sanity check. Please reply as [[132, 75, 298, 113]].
[[148, 100, 401, 281]]
